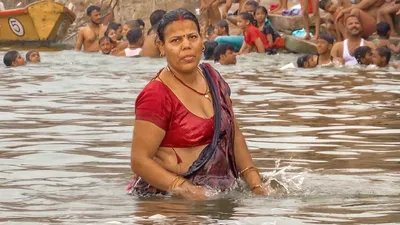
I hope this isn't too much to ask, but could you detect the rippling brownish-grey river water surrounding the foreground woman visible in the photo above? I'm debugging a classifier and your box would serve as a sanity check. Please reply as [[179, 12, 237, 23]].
[[0, 51, 400, 225]]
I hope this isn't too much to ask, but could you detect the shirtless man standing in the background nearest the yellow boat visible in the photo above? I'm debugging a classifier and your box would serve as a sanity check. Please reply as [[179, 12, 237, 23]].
[[75, 5, 107, 52]]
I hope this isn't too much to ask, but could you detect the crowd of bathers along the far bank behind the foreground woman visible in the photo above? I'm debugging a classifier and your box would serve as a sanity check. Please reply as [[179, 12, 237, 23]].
[[4, 0, 400, 68]]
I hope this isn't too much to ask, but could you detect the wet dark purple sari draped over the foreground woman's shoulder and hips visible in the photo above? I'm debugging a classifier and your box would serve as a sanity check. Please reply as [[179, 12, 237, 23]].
[[127, 63, 238, 195]]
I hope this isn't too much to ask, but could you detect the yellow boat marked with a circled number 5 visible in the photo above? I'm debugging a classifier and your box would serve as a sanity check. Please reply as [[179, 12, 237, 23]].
[[0, 1, 76, 46]]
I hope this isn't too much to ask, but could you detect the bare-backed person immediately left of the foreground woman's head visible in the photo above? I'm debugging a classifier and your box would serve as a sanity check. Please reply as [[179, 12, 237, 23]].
[[142, 9, 166, 57]]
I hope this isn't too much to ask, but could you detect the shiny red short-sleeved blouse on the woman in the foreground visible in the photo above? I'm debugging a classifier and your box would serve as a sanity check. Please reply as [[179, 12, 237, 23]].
[[135, 80, 214, 148]]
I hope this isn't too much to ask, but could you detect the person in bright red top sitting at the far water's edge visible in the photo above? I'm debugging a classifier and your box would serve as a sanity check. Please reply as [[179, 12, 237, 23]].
[[237, 12, 271, 54]]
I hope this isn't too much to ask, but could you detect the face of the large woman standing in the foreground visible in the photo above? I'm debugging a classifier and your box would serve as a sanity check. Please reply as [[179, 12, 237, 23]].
[[159, 20, 204, 73]]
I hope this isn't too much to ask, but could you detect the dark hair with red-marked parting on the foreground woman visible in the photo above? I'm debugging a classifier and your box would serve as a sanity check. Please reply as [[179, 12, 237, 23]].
[[157, 8, 200, 42]]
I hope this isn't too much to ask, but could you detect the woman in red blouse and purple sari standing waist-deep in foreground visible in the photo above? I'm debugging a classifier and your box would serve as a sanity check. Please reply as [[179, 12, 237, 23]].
[[128, 9, 268, 199]]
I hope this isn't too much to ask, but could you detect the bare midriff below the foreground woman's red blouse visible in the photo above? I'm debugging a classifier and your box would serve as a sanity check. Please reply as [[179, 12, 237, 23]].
[[154, 145, 207, 175]]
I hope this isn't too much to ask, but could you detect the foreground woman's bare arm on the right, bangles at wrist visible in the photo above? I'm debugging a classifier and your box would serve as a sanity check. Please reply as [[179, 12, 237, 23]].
[[234, 120, 268, 195]]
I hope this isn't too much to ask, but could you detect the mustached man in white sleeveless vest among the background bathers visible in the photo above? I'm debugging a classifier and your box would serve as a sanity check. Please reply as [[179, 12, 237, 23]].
[[331, 15, 376, 65]]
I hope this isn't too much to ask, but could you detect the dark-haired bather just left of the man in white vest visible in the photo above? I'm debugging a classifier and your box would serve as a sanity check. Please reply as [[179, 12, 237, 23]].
[[317, 34, 344, 65]]
